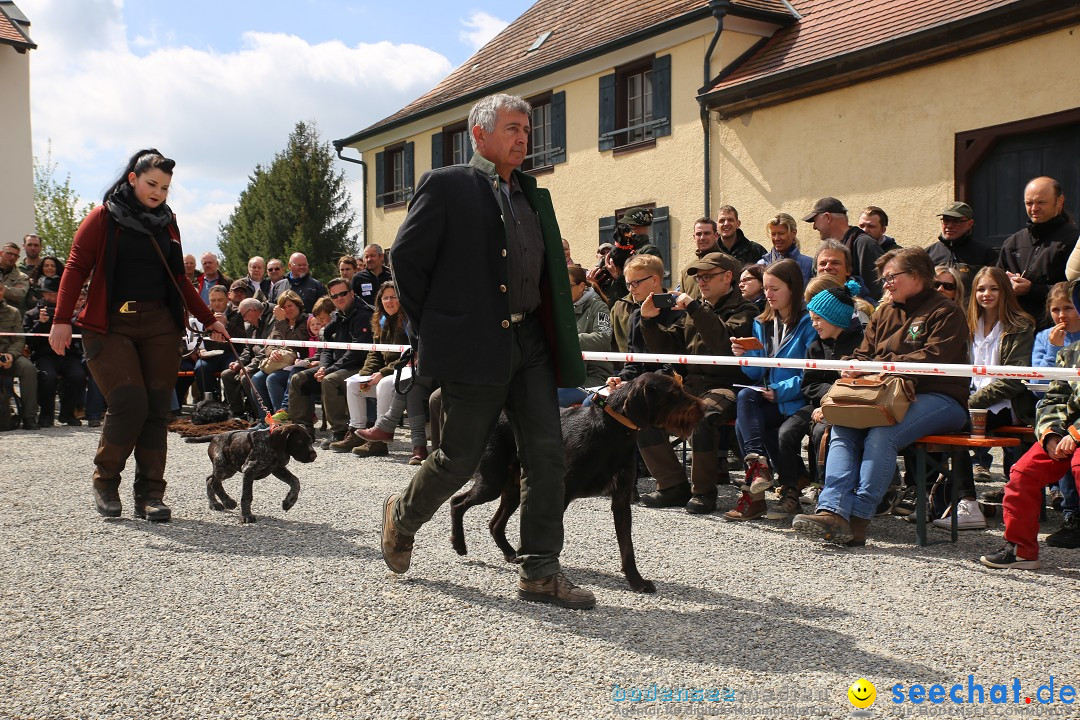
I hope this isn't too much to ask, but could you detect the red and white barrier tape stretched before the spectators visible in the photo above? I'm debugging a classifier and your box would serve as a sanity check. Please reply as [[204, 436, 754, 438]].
[[0, 332, 1080, 382]]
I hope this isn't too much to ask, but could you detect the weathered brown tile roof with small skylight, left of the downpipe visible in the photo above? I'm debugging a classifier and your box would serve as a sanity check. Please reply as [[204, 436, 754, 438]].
[[335, 0, 794, 145]]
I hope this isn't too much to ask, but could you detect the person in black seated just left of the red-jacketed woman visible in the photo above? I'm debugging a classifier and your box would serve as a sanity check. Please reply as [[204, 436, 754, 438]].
[[23, 275, 86, 427]]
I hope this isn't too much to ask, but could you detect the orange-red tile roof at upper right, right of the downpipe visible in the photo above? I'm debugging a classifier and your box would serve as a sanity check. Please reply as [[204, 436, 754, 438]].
[[710, 0, 1065, 99]]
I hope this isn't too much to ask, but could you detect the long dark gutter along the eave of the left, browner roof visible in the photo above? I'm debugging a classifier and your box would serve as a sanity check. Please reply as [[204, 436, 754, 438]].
[[334, 3, 795, 146]]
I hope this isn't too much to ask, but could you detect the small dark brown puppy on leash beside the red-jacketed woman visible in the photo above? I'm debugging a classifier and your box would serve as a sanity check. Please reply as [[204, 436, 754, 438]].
[[187, 423, 316, 522]]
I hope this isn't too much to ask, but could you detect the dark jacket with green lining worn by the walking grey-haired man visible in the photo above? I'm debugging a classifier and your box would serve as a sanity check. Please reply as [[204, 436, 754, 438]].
[[391, 153, 585, 388]]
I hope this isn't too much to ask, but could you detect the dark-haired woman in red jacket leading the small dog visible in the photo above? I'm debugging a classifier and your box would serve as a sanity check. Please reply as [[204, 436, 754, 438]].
[[49, 149, 228, 521]]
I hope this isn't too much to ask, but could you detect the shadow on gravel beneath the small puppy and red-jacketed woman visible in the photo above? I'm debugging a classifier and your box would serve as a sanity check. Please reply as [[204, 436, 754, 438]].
[[120, 515, 382, 561]]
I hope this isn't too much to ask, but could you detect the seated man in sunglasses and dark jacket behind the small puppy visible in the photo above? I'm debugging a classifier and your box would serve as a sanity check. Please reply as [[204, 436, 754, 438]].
[[287, 278, 372, 442]]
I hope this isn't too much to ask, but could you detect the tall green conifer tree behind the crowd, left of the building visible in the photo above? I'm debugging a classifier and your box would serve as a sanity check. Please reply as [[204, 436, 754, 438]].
[[217, 122, 356, 281]]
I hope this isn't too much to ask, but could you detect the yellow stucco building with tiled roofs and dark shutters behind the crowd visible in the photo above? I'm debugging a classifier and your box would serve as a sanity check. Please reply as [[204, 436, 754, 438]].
[[335, 0, 1080, 277]]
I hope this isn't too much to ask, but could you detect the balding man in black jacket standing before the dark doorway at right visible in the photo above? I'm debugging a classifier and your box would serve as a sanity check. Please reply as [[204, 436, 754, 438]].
[[998, 177, 1080, 330]]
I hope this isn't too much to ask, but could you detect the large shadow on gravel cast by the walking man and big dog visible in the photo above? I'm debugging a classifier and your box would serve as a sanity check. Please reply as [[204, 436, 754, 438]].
[[409, 568, 936, 677]]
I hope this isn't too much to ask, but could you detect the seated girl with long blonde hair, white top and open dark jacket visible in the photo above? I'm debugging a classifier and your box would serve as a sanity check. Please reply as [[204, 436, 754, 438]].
[[963, 266, 1035, 515]]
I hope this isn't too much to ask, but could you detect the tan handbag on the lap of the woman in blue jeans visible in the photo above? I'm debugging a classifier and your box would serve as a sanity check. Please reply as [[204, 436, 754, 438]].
[[821, 375, 915, 427]]
